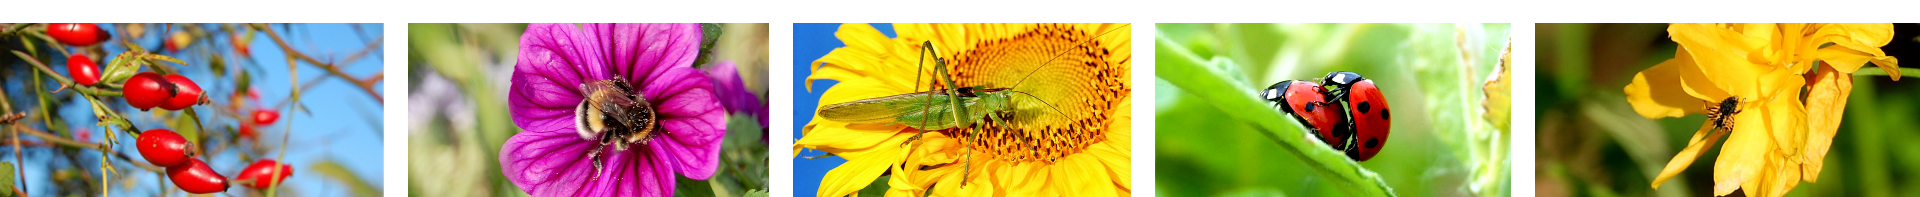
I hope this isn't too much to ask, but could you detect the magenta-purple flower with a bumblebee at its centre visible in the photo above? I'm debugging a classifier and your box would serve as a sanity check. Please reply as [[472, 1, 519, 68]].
[[499, 23, 726, 197]]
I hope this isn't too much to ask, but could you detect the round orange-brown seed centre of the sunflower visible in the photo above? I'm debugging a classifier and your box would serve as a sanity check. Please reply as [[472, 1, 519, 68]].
[[948, 25, 1133, 163]]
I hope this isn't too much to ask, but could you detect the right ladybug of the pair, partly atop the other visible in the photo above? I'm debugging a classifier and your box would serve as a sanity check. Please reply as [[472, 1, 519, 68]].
[[1321, 71, 1392, 161]]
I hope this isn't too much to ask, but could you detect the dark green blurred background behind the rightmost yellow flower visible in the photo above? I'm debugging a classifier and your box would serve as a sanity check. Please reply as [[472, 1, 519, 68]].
[[1530, 23, 1920, 197]]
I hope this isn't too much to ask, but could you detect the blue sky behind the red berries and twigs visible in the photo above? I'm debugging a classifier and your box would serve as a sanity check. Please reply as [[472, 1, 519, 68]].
[[25, 23, 392, 197]]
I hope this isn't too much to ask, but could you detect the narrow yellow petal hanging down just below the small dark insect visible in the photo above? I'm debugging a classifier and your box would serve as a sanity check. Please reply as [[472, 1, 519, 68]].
[[1713, 109, 1774, 195]]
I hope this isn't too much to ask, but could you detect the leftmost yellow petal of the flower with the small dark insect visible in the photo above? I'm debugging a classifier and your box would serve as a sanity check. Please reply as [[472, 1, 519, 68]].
[[1626, 50, 1705, 119]]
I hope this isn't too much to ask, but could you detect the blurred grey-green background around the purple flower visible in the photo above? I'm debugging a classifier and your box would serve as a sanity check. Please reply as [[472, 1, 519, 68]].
[[405, 23, 770, 197]]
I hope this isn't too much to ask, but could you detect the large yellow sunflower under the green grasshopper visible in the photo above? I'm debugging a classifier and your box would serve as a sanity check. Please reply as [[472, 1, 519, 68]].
[[793, 23, 1133, 197]]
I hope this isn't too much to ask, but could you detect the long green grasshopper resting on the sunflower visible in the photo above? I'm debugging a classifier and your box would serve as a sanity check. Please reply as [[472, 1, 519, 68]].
[[818, 25, 1125, 186]]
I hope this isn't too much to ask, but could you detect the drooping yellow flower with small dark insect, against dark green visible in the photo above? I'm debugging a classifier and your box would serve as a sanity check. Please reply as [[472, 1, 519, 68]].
[[1624, 23, 1899, 197]]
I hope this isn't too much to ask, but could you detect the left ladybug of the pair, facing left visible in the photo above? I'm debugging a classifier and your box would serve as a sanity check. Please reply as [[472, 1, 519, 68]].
[[1260, 80, 1354, 149]]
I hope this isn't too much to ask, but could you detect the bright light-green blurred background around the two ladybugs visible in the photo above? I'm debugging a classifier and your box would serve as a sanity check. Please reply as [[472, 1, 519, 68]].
[[1152, 23, 1511, 197]]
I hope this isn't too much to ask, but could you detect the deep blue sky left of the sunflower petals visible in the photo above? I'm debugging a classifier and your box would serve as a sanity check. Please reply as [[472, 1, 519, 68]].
[[787, 23, 895, 197]]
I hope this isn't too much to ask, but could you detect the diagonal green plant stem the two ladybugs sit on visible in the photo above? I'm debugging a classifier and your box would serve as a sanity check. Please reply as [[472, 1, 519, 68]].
[[1154, 29, 1394, 197]]
